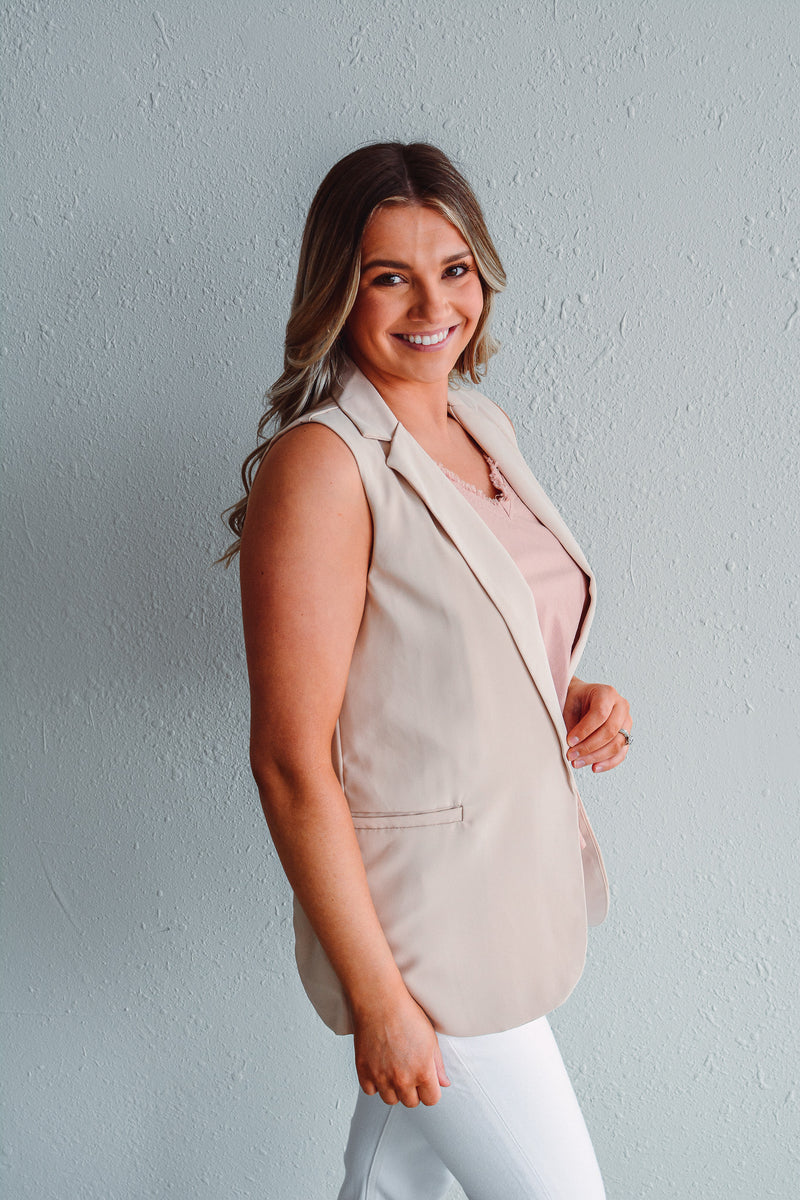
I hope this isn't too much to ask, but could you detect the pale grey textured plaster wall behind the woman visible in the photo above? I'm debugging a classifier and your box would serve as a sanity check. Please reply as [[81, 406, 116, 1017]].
[[0, 0, 800, 1200]]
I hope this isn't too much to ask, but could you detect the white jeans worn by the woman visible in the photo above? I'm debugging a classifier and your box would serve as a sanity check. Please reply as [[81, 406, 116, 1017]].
[[339, 1016, 606, 1200]]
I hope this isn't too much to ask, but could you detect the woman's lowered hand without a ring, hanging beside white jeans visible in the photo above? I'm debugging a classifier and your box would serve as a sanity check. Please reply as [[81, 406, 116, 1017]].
[[354, 988, 450, 1109]]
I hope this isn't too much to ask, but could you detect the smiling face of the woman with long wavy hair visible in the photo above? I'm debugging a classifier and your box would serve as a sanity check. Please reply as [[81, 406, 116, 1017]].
[[344, 205, 483, 390]]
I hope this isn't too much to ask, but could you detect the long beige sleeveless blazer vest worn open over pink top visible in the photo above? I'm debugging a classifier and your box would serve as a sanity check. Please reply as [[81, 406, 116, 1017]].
[[272, 366, 608, 1036]]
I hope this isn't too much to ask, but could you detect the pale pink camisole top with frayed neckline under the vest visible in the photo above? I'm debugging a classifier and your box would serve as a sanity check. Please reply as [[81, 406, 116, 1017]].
[[438, 455, 589, 708]]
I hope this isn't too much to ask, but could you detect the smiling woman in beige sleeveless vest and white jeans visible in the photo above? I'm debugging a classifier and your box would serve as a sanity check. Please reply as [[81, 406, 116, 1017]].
[[221, 143, 630, 1200]]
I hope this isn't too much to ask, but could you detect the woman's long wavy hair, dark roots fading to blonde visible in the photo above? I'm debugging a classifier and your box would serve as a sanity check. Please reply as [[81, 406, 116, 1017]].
[[219, 142, 506, 566]]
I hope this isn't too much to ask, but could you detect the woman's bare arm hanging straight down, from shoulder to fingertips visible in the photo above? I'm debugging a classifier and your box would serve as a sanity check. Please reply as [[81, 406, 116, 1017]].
[[241, 425, 446, 1105]]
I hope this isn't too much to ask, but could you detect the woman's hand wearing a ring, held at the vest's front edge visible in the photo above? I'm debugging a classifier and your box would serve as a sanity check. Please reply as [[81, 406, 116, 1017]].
[[564, 677, 631, 772]]
